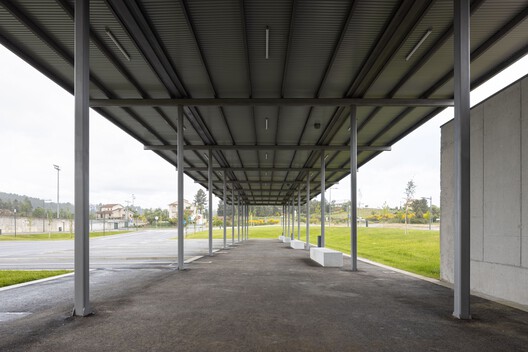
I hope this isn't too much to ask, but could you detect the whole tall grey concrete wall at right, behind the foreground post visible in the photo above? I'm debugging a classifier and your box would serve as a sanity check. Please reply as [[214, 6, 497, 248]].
[[440, 77, 528, 305]]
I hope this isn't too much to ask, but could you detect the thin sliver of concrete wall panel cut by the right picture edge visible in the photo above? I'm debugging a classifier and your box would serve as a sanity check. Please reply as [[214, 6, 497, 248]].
[[521, 79, 528, 270]]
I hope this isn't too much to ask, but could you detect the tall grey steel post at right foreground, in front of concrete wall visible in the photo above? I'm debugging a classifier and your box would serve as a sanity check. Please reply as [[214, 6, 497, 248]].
[[453, 0, 471, 319]]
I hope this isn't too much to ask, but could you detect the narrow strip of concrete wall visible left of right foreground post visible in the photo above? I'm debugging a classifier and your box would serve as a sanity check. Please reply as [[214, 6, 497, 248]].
[[440, 121, 455, 282]]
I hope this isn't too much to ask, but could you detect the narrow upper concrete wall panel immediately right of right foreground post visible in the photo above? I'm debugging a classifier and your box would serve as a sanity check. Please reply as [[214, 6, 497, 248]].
[[471, 105, 484, 260]]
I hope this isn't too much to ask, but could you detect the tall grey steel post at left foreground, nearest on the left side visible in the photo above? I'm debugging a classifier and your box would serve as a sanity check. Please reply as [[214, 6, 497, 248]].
[[73, 0, 92, 316]]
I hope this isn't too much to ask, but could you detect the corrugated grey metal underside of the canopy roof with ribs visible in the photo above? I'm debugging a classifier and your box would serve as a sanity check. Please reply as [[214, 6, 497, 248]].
[[0, 0, 528, 205]]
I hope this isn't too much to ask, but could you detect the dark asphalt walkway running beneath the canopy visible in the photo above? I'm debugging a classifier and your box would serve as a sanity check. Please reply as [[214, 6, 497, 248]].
[[0, 240, 528, 351]]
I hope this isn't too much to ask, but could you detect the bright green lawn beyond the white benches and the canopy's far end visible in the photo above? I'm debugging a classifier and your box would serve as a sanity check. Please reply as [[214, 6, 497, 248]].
[[187, 226, 440, 279]]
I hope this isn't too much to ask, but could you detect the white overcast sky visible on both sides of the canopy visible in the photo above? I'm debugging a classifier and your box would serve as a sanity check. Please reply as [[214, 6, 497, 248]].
[[0, 45, 528, 208]]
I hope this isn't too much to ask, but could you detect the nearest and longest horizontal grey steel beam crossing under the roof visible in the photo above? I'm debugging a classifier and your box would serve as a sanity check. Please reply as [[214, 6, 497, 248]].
[[90, 98, 454, 108]]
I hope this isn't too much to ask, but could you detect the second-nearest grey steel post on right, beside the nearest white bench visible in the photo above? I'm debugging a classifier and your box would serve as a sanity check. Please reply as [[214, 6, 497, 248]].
[[347, 105, 357, 271]]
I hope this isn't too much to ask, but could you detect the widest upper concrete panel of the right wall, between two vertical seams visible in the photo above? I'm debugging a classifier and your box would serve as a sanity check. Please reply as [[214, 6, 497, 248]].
[[483, 84, 521, 265]]
